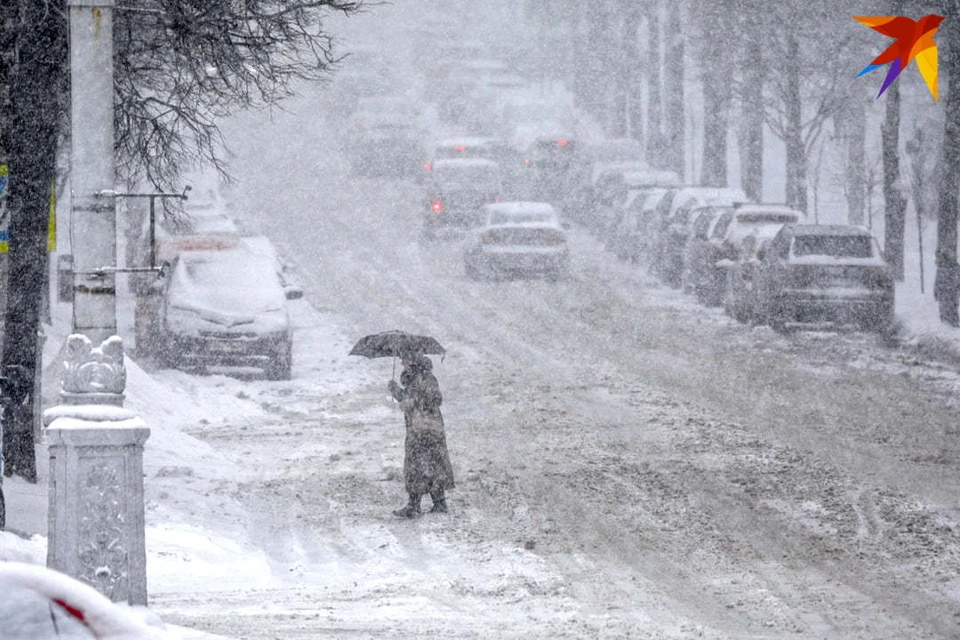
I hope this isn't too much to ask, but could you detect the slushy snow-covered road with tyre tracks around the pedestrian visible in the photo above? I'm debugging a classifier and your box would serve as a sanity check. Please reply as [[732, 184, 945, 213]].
[[146, 95, 960, 640]]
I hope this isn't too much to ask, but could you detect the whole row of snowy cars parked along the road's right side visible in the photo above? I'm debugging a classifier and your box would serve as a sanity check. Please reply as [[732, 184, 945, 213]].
[[580, 169, 894, 333]]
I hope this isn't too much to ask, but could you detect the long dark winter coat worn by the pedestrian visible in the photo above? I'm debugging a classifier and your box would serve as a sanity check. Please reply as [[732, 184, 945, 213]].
[[393, 358, 454, 495]]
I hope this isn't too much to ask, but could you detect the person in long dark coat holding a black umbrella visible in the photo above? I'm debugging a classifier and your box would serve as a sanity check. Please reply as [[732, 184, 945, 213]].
[[350, 331, 454, 518]]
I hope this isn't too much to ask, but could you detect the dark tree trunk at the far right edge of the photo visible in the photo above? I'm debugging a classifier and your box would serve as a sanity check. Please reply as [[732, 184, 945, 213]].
[[936, 10, 960, 327]]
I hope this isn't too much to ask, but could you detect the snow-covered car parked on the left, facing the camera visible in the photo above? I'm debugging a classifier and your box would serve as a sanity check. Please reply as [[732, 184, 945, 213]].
[[157, 249, 295, 380]]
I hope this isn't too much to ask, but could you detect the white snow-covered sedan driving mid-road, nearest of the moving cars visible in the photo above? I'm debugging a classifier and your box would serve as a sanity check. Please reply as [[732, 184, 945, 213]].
[[463, 202, 570, 279]]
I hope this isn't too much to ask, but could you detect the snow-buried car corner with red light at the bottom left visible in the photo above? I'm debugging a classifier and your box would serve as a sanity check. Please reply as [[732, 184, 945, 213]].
[[0, 562, 169, 640]]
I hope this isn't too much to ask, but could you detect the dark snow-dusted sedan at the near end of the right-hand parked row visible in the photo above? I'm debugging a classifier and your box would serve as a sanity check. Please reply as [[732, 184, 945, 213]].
[[759, 224, 894, 331]]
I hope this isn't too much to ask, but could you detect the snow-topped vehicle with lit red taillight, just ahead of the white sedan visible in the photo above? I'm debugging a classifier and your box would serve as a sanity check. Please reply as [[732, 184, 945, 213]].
[[423, 158, 502, 239]]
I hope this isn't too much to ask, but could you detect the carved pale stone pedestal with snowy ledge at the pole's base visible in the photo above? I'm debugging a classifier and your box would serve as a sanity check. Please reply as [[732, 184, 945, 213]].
[[44, 334, 150, 605]]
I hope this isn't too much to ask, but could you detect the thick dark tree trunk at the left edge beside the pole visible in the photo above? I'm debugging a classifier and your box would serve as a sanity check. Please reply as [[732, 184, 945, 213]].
[[0, 1, 67, 482]]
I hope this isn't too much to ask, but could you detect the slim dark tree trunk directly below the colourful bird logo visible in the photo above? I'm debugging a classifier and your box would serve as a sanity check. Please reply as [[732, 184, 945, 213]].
[[880, 82, 907, 281]]
